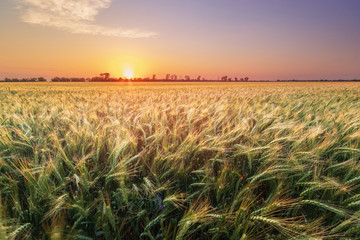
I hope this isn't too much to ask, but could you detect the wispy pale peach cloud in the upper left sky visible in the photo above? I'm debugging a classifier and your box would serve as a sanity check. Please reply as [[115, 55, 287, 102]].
[[19, 0, 156, 38]]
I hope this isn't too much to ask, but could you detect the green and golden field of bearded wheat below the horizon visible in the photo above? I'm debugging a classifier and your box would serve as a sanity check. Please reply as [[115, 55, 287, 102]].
[[0, 83, 360, 240]]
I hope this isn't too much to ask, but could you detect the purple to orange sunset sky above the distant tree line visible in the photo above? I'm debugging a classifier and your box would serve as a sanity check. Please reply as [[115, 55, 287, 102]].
[[0, 0, 360, 80]]
